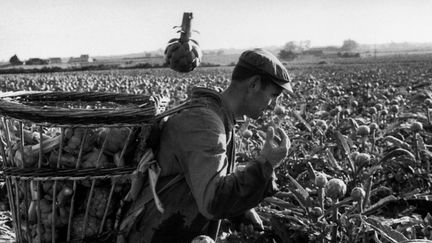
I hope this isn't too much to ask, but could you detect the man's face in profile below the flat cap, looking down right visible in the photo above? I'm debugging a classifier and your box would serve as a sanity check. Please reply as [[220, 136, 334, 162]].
[[246, 78, 282, 119]]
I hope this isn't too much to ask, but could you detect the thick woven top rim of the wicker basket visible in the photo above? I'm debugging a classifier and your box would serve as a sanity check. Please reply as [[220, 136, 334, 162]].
[[0, 91, 159, 125]]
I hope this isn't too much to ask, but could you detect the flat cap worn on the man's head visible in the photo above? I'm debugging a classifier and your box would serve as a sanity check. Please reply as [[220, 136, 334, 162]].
[[237, 48, 294, 93]]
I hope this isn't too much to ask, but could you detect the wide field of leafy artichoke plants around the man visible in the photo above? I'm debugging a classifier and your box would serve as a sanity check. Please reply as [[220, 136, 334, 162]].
[[0, 55, 432, 242]]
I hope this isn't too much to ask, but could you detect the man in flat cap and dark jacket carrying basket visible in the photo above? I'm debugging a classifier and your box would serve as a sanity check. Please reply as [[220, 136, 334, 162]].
[[122, 49, 292, 243]]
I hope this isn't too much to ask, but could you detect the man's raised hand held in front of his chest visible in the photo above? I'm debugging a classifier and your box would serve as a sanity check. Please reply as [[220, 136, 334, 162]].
[[257, 127, 291, 168]]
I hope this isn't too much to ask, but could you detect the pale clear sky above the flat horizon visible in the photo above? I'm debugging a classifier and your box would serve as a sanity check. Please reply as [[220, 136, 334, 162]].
[[0, 0, 432, 60]]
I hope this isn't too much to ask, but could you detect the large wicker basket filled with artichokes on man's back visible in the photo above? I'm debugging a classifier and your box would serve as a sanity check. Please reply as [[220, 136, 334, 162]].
[[0, 92, 167, 242]]
